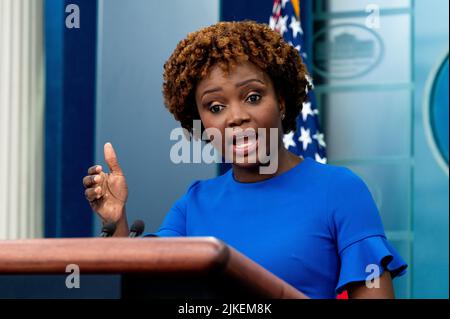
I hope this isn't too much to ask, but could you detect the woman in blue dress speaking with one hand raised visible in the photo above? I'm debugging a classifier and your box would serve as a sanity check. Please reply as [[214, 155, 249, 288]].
[[83, 21, 406, 298]]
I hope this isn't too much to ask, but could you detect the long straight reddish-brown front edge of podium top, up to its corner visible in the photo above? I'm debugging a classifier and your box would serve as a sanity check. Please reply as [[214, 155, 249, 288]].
[[0, 237, 230, 274]]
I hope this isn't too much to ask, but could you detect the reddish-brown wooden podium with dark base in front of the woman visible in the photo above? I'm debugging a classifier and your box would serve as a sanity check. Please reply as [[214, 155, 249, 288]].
[[0, 237, 307, 299]]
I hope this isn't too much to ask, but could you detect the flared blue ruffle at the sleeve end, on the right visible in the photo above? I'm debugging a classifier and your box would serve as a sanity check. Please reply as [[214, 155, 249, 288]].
[[336, 236, 408, 294]]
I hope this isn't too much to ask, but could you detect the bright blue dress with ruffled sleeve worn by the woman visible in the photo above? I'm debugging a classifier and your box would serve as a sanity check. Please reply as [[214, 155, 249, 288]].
[[148, 158, 407, 298]]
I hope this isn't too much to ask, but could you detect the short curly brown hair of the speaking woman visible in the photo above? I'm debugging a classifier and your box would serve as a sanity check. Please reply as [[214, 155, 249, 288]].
[[163, 21, 312, 138]]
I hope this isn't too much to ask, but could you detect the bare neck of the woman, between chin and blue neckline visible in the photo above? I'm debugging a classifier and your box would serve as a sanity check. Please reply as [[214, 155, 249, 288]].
[[233, 147, 303, 183]]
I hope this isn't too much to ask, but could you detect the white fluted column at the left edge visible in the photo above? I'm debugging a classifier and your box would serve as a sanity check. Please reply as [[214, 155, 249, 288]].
[[0, 0, 44, 239]]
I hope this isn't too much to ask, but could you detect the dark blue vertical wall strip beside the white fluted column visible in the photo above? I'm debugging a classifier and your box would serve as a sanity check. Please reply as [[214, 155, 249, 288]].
[[44, 0, 97, 237]]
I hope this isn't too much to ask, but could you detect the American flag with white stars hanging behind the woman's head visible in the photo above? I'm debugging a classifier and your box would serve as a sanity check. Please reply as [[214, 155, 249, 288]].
[[269, 0, 327, 163]]
